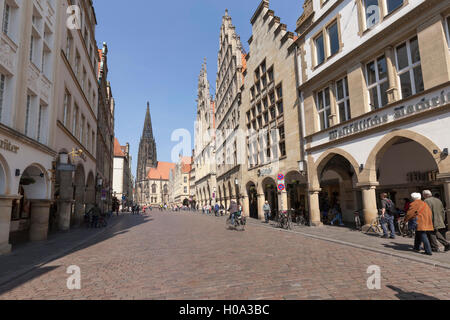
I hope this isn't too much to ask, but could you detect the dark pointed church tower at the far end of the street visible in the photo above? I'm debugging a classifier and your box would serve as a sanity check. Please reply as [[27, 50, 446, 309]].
[[136, 102, 158, 182]]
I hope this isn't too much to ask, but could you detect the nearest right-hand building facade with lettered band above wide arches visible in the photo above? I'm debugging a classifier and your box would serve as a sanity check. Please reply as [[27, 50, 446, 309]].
[[294, 0, 450, 230]]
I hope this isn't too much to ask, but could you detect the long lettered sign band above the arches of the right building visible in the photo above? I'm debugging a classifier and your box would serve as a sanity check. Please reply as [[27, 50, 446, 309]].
[[329, 90, 450, 141]]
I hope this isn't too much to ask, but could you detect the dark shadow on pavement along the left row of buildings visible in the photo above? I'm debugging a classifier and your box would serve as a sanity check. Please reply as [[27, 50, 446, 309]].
[[0, 215, 154, 296]]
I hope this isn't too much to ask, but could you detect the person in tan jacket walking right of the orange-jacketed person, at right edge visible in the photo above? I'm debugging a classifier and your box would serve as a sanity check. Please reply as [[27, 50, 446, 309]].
[[422, 190, 450, 252]]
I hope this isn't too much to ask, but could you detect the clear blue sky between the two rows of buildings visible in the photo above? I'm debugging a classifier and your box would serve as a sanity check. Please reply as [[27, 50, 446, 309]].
[[94, 0, 303, 175]]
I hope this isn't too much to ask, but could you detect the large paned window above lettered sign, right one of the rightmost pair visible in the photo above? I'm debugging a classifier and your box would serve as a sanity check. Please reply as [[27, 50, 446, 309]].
[[395, 37, 424, 99]]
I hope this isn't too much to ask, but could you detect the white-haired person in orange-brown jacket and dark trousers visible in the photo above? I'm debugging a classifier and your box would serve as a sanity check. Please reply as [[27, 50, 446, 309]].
[[405, 193, 434, 256]]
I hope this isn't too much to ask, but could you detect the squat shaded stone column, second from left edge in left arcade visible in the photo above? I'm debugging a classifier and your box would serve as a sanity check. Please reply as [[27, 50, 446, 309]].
[[29, 200, 51, 241]]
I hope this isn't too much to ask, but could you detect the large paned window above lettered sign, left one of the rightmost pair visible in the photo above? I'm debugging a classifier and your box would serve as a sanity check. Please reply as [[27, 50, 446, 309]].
[[366, 56, 389, 110]]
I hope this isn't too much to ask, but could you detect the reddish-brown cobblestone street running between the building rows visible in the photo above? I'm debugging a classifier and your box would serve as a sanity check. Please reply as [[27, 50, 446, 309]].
[[0, 211, 450, 300]]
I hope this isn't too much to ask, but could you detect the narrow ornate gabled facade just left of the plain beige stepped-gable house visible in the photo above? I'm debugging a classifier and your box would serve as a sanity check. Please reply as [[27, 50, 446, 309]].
[[215, 10, 246, 208]]
